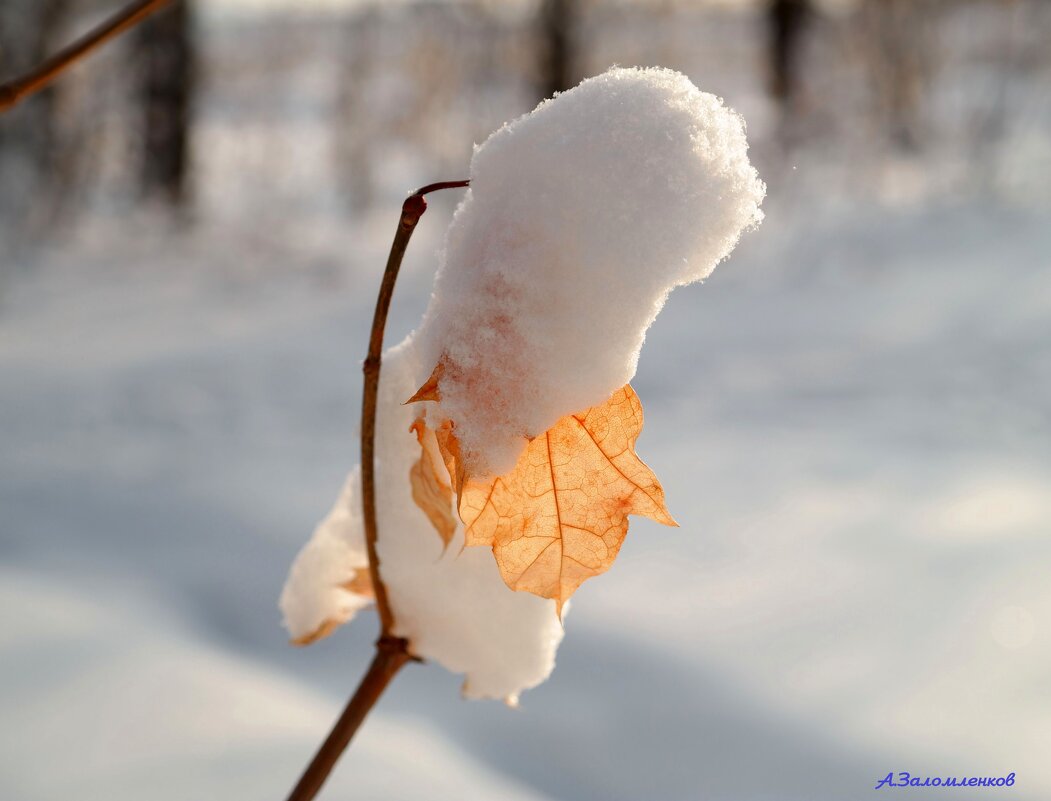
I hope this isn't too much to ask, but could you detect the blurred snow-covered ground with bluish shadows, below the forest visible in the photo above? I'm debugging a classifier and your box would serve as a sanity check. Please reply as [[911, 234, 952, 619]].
[[0, 4, 1051, 801]]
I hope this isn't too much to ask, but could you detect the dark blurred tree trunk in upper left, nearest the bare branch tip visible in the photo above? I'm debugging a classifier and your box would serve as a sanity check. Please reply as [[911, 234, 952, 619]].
[[132, 0, 197, 206]]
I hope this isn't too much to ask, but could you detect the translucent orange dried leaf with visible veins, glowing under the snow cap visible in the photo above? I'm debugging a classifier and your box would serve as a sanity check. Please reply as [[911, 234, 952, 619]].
[[435, 386, 677, 615]]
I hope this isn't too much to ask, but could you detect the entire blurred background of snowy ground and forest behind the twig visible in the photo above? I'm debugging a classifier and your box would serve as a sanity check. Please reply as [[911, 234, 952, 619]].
[[0, 0, 1051, 801]]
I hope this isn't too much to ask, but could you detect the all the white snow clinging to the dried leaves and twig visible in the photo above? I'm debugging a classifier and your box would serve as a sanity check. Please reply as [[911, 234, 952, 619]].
[[282, 69, 765, 700]]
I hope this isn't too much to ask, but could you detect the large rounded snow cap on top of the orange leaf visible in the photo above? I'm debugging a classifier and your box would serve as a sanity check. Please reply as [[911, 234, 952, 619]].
[[417, 68, 766, 474]]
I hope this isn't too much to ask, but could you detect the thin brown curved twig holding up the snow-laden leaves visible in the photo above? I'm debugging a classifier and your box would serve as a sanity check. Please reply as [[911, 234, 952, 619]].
[[288, 181, 469, 801]]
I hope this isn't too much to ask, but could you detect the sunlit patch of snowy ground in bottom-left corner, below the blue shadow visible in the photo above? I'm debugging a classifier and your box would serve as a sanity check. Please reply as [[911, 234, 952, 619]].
[[0, 568, 544, 801]]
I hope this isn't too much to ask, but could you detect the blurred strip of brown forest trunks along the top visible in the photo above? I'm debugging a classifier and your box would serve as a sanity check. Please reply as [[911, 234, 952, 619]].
[[0, 0, 1051, 255]]
